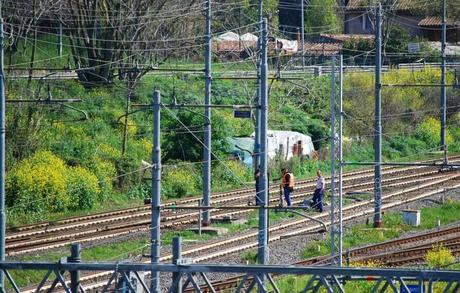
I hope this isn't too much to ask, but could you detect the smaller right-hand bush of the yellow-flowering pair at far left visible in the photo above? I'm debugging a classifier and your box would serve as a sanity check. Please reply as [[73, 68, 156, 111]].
[[67, 167, 101, 211]]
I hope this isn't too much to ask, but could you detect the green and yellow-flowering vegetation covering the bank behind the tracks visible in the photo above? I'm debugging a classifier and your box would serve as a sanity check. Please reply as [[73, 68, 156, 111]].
[[6, 65, 460, 221]]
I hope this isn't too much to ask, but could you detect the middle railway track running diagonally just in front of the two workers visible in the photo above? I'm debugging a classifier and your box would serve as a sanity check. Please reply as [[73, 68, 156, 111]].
[[65, 173, 460, 290]]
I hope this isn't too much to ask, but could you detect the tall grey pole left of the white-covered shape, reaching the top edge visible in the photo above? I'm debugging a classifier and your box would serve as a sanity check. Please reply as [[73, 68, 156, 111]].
[[203, 0, 212, 226]]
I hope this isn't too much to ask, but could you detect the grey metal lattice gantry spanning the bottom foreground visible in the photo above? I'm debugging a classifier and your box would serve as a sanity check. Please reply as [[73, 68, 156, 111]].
[[0, 254, 460, 293]]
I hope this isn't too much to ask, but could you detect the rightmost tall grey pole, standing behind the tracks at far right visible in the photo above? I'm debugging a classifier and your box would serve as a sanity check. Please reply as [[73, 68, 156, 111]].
[[440, 0, 448, 165]]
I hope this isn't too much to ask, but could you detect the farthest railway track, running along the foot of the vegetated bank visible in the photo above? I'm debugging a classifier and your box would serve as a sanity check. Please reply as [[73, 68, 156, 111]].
[[6, 163, 452, 256]]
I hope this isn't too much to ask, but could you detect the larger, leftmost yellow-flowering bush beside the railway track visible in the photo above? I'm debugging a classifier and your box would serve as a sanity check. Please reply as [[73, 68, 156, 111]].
[[6, 151, 69, 212]]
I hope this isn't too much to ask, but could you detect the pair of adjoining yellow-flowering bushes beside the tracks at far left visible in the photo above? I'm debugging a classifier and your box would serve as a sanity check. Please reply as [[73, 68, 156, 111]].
[[6, 151, 101, 213]]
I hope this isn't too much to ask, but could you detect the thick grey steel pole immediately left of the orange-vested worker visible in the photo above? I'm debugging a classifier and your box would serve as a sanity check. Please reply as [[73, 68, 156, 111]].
[[257, 18, 269, 292]]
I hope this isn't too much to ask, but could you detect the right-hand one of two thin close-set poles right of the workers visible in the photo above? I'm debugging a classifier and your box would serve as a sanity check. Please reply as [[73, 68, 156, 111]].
[[337, 55, 343, 267]]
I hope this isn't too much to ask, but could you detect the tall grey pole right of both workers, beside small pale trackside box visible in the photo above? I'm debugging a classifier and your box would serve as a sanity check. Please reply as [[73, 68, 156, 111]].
[[374, 3, 382, 228]]
